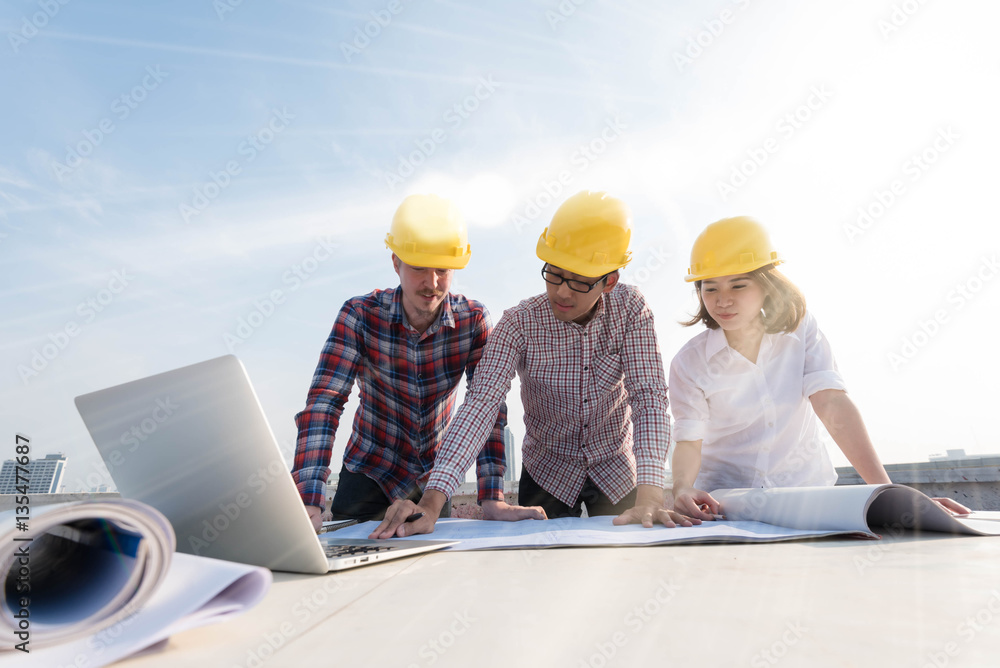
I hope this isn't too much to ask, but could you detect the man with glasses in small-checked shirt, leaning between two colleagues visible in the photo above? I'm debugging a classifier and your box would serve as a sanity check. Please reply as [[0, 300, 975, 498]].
[[371, 191, 700, 538]]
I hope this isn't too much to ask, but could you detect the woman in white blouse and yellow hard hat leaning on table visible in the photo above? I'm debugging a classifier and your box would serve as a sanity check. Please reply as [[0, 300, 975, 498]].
[[669, 217, 968, 520]]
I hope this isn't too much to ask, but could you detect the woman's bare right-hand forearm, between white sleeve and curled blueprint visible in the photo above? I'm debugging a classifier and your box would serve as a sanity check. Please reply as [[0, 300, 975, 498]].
[[809, 390, 892, 485]]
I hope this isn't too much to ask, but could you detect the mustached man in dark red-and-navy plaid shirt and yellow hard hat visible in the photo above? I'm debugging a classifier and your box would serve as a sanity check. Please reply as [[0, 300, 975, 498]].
[[292, 195, 544, 530]]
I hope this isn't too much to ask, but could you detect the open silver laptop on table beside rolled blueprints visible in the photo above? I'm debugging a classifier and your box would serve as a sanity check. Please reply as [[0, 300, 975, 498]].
[[76, 355, 455, 573]]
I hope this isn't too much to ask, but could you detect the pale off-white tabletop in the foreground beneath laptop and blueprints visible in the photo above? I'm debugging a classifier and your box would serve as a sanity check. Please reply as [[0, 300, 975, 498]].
[[116, 534, 1000, 668]]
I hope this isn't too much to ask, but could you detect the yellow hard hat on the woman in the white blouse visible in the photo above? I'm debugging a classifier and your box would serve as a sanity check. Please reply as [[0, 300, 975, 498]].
[[684, 216, 784, 283]]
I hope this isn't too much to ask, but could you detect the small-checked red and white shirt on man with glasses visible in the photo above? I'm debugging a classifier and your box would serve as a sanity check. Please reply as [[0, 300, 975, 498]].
[[427, 283, 670, 505]]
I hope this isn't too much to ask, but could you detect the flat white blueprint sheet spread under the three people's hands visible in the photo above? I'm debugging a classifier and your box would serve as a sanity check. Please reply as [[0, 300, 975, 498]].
[[334, 516, 864, 551]]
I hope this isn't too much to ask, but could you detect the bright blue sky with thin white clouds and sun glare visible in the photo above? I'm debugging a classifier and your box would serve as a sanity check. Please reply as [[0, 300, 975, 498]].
[[0, 0, 1000, 490]]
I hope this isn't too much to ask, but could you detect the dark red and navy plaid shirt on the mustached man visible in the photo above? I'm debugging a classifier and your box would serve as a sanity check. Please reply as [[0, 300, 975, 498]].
[[292, 288, 507, 507]]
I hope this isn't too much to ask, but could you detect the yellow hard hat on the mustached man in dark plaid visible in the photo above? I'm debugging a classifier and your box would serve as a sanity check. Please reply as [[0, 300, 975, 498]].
[[385, 195, 472, 269]]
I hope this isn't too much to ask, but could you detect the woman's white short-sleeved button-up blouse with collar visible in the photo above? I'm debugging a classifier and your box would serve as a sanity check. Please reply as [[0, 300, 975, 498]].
[[669, 312, 846, 492]]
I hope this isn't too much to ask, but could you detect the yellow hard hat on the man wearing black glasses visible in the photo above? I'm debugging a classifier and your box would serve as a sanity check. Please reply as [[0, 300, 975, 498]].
[[535, 190, 632, 278]]
